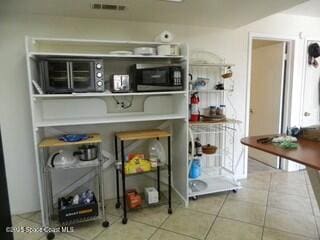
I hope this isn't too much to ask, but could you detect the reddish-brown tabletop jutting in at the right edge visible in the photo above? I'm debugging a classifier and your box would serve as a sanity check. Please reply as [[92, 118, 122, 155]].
[[241, 136, 320, 170]]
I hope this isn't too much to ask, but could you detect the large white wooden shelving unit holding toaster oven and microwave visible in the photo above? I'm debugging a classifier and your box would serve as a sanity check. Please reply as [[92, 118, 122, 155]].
[[26, 37, 189, 237]]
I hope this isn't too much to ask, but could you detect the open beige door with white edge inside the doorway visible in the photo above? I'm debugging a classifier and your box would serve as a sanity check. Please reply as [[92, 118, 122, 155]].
[[249, 40, 285, 168]]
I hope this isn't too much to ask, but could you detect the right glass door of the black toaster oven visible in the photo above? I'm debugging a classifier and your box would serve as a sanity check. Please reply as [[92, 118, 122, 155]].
[[70, 61, 95, 92]]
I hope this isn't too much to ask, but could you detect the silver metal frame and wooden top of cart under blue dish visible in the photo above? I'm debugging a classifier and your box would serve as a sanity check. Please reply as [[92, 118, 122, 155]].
[[39, 134, 109, 239]]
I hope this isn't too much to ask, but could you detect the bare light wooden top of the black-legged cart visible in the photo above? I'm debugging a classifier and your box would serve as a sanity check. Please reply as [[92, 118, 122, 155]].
[[116, 129, 171, 141]]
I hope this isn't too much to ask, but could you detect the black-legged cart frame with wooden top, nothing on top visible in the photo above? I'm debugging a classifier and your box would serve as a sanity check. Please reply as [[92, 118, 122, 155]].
[[114, 129, 172, 224]]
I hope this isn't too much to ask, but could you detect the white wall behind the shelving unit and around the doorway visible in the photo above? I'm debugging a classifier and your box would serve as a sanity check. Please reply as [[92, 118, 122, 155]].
[[0, 13, 320, 213]]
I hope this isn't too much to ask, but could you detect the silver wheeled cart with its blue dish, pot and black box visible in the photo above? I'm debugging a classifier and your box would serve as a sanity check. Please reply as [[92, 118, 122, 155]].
[[39, 134, 109, 239]]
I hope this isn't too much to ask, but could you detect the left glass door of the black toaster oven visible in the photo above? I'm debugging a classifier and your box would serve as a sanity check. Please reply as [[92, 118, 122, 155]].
[[45, 60, 70, 93]]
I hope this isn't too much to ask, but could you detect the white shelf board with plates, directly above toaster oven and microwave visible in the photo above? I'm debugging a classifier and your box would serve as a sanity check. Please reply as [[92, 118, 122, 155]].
[[29, 52, 184, 59]]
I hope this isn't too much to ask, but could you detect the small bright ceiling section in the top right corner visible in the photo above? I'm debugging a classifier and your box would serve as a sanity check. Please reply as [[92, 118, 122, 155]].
[[285, 0, 320, 17]]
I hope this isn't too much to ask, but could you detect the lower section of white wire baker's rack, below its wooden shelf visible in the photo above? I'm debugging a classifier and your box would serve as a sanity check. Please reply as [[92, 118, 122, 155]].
[[189, 120, 240, 200]]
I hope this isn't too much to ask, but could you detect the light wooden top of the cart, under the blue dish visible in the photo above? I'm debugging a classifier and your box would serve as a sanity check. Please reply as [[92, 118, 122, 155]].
[[39, 133, 102, 148]]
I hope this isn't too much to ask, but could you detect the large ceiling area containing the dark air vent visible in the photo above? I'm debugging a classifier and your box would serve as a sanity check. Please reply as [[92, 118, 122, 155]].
[[0, 0, 306, 28]]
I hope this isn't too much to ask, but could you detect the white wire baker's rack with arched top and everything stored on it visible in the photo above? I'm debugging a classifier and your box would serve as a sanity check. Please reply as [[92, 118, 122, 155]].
[[188, 51, 240, 199]]
